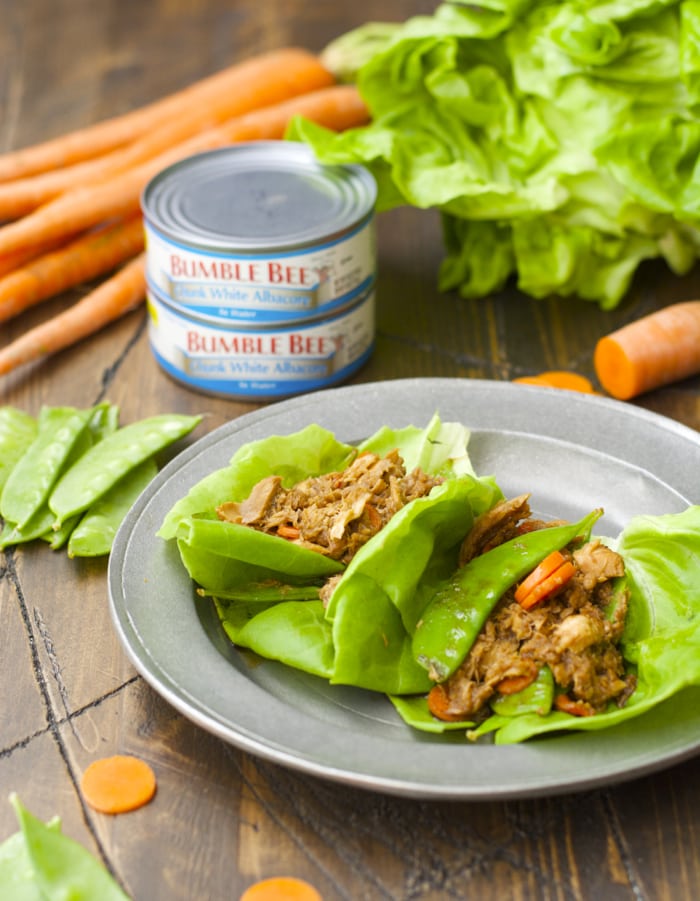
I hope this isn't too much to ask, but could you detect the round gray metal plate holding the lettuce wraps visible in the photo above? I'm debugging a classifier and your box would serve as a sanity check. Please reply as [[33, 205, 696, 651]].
[[109, 379, 700, 800]]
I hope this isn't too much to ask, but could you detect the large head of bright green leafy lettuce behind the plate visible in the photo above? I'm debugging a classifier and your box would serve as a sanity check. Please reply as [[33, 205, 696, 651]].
[[287, 0, 700, 309]]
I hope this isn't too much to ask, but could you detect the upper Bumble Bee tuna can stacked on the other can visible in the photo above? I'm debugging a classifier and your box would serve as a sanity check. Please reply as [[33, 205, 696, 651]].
[[141, 141, 377, 325]]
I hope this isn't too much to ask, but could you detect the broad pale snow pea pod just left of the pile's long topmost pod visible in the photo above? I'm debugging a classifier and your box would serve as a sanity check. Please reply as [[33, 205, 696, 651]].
[[0, 407, 93, 531]]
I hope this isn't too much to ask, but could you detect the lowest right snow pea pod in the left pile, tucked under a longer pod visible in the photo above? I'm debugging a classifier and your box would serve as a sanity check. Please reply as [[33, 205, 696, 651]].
[[66, 459, 158, 557]]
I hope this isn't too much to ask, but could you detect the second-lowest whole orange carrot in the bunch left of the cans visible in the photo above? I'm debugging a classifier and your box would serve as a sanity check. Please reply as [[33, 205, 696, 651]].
[[0, 216, 144, 322]]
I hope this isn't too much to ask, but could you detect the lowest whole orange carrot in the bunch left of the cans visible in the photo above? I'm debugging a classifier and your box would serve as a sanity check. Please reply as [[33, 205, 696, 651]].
[[0, 254, 146, 375]]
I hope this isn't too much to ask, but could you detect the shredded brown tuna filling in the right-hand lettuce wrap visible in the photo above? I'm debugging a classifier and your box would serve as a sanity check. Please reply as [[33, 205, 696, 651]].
[[432, 496, 635, 719]]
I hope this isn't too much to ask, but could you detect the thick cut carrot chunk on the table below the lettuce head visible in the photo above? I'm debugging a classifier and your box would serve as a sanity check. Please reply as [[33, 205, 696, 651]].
[[593, 300, 700, 400]]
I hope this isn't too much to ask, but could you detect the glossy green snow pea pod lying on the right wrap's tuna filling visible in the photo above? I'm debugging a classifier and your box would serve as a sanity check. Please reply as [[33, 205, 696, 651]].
[[413, 510, 603, 682]]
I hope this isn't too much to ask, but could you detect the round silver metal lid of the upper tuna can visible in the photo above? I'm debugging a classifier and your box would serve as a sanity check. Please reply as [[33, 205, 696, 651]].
[[142, 141, 377, 250]]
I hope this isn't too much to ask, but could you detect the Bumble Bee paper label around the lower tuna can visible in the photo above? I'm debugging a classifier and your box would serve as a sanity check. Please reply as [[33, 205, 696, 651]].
[[148, 290, 375, 400]]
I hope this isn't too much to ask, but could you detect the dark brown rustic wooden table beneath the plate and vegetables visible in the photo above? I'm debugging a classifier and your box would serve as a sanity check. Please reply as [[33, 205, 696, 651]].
[[0, 0, 700, 901]]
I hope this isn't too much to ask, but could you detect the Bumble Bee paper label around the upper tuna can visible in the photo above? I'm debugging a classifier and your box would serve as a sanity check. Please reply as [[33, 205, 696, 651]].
[[145, 217, 376, 324]]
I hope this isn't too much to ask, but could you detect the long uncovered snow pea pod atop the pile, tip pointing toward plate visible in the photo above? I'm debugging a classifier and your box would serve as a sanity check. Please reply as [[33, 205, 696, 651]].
[[49, 414, 202, 526]]
